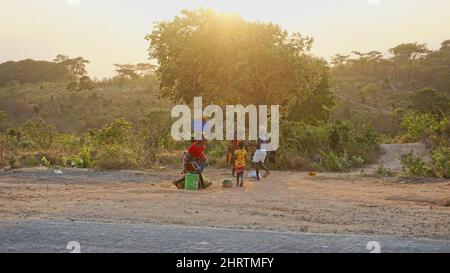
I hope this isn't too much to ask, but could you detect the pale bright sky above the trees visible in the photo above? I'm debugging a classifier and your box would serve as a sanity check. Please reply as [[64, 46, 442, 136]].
[[0, 0, 450, 78]]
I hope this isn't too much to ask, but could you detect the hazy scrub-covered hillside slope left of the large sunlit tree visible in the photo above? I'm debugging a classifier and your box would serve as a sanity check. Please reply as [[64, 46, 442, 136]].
[[0, 78, 170, 133]]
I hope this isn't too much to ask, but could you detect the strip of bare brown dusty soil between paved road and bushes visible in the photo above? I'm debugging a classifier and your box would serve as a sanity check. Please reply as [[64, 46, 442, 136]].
[[0, 165, 450, 239]]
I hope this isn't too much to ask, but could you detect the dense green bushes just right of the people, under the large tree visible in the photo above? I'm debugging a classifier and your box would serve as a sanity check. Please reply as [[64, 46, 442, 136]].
[[276, 119, 380, 171]]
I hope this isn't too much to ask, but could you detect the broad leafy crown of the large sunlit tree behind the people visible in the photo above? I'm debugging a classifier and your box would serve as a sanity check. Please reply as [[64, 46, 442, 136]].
[[147, 9, 331, 119]]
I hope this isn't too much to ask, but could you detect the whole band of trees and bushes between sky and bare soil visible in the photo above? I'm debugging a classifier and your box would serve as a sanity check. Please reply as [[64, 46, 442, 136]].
[[0, 9, 450, 177]]
